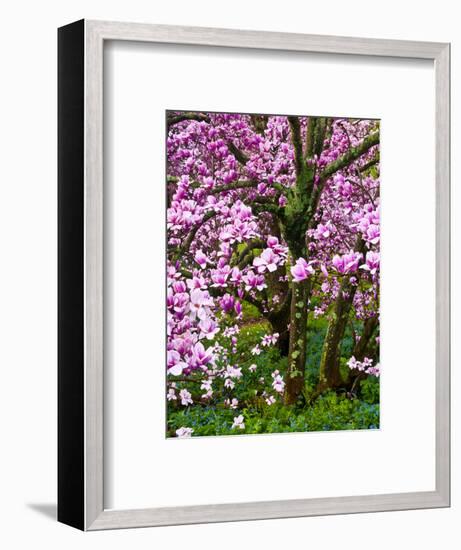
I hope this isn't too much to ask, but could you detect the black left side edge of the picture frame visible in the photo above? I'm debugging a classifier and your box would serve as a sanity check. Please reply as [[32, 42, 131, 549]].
[[58, 20, 85, 529]]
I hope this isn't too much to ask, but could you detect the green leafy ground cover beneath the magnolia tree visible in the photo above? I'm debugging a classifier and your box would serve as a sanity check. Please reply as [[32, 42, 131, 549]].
[[167, 310, 379, 437]]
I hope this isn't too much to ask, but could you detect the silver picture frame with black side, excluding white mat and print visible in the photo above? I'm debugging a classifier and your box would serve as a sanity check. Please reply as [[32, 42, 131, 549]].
[[58, 20, 450, 531]]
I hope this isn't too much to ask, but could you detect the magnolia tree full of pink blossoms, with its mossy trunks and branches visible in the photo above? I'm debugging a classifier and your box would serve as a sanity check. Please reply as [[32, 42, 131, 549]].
[[167, 112, 380, 435]]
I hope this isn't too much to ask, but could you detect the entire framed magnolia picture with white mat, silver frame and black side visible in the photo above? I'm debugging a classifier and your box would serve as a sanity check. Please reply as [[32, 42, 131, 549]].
[[58, 20, 450, 530]]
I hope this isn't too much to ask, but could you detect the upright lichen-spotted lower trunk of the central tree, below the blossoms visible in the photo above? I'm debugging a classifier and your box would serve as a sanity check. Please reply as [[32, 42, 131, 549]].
[[285, 280, 310, 405]]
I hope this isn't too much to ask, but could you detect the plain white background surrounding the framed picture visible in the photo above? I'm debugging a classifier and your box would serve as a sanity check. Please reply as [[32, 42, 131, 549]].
[[0, 0, 461, 550]]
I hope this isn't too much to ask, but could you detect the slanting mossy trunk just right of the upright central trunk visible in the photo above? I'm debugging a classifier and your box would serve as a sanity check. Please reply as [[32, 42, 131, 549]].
[[318, 278, 357, 392]]
